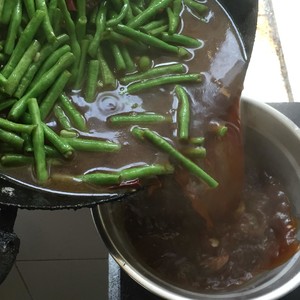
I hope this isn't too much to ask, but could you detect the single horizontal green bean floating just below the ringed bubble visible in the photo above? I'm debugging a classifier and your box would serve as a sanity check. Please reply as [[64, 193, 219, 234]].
[[107, 113, 171, 126]]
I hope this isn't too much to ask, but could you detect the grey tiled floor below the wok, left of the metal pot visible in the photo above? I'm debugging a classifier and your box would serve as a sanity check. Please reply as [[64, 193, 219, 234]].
[[0, 209, 108, 300]]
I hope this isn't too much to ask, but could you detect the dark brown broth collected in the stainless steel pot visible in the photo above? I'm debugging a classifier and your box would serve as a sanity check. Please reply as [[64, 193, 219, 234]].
[[104, 165, 299, 292]]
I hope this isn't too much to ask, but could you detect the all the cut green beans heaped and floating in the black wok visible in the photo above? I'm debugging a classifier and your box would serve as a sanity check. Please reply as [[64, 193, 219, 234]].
[[0, 0, 217, 187]]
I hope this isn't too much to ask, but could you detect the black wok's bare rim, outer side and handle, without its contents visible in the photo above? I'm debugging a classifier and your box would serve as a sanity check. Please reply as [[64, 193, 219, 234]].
[[0, 0, 258, 283]]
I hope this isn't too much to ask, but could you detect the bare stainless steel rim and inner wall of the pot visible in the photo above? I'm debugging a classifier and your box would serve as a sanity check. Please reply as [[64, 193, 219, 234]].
[[93, 99, 300, 300]]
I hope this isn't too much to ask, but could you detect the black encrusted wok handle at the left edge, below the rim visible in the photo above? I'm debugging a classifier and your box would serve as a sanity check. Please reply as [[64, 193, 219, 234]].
[[0, 206, 20, 284]]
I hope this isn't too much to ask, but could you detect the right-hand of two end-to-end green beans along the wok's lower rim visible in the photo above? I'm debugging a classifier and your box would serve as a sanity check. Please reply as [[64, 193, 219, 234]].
[[120, 164, 174, 182]]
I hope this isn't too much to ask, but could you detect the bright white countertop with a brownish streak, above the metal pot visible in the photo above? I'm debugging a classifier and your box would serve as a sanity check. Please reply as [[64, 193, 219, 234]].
[[243, 0, 300, 102]]
